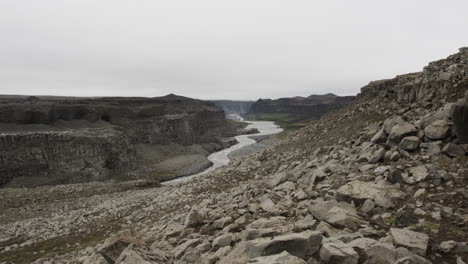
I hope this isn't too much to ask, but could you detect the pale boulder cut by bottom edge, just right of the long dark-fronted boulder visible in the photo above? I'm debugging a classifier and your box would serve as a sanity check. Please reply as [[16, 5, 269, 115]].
[[320, 240, 359, 264]]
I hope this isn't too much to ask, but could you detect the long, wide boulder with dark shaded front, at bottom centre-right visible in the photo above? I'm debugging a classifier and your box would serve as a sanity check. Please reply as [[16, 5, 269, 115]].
[[247, 231, 322, 259]]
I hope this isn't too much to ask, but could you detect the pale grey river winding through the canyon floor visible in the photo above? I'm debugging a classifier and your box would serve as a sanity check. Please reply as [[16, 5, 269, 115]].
[[162, 118, 283, 185]]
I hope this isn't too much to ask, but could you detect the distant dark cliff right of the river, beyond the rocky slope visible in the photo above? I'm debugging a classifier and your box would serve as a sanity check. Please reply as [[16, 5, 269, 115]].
[[248, 94, 354, 119]]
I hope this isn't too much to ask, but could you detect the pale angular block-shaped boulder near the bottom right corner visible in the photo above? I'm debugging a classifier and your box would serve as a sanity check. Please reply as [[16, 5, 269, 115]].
[[390, 228, 429, 256]]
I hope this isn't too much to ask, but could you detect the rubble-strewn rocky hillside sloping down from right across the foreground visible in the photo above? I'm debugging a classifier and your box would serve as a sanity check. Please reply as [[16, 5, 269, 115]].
[[0, 48, 468, 264]]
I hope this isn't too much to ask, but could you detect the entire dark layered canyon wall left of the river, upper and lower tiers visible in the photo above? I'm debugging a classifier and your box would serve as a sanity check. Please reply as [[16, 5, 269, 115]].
[[0, 95, 232, 186]]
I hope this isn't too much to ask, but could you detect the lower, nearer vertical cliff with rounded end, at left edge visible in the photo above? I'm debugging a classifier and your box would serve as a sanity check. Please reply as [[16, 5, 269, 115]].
[[0, 129, 135, 186]]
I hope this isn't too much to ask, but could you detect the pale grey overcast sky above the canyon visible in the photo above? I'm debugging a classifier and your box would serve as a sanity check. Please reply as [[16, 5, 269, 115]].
[[0, 0, 468, 99]]
